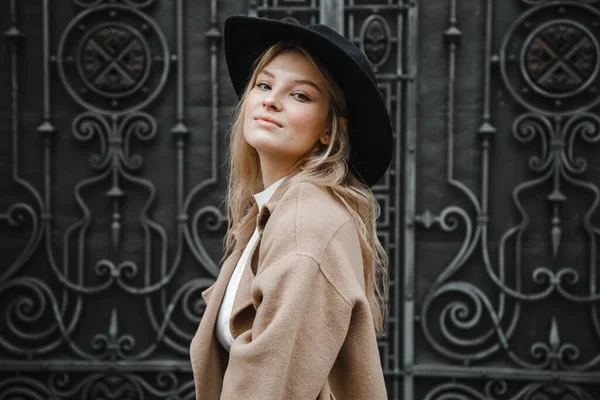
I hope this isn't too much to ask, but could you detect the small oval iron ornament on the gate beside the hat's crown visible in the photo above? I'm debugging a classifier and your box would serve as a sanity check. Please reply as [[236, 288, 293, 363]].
[[359, 15, 392, 68]]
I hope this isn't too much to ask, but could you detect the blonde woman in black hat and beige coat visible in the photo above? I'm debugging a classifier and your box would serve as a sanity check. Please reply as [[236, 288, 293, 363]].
[[190, 16, 392, 400]]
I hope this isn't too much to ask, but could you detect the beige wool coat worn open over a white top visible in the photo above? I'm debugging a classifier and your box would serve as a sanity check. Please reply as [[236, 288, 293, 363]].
[[190, 179, 387, 400]]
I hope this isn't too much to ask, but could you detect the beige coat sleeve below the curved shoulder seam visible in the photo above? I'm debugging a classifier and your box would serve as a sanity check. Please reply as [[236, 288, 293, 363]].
[[221, 254, 352, 400]]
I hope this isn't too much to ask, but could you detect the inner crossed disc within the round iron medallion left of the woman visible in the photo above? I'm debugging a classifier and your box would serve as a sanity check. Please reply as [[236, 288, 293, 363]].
[[77, 23, 151, 98]]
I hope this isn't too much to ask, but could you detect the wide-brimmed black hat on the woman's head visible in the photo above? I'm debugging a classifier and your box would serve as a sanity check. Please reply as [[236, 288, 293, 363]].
[[225, 16, 393, 186]]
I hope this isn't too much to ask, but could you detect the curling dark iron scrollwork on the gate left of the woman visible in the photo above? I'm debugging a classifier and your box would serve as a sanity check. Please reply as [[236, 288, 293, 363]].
[[0, 0, 226, 399]]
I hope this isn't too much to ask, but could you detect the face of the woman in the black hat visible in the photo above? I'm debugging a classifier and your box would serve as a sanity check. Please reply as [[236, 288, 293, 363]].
[[243, 51, 330, 168]]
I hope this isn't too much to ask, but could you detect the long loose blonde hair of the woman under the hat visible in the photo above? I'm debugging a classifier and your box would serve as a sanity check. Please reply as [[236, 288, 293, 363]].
[[225, 42, 388, 334]]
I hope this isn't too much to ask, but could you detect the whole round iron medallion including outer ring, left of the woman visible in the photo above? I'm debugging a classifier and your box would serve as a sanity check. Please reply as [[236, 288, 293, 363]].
[[56, 4, 170, 115]]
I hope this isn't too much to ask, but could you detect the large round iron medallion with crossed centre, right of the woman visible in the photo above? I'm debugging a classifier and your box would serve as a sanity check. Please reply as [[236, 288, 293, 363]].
[[499, 1, 600, 115]]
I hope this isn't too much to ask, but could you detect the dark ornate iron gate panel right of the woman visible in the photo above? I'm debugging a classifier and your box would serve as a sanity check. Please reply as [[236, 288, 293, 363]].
[[412, 0, 600, 400]]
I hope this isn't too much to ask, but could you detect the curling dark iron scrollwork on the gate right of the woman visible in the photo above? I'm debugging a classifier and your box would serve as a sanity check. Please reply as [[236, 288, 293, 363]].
[[416, 2, 600, 382]]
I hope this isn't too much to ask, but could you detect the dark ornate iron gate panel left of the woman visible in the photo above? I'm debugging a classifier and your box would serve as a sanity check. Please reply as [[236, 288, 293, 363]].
[[0, 0, 234, 399]]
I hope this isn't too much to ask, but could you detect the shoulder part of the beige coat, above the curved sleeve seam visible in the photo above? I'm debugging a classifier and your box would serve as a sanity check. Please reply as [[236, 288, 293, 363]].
[[260, 183, 364, 298]]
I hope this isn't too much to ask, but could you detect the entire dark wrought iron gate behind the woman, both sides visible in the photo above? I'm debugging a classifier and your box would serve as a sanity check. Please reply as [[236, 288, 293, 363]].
[[0, 0, 600, 400]]
